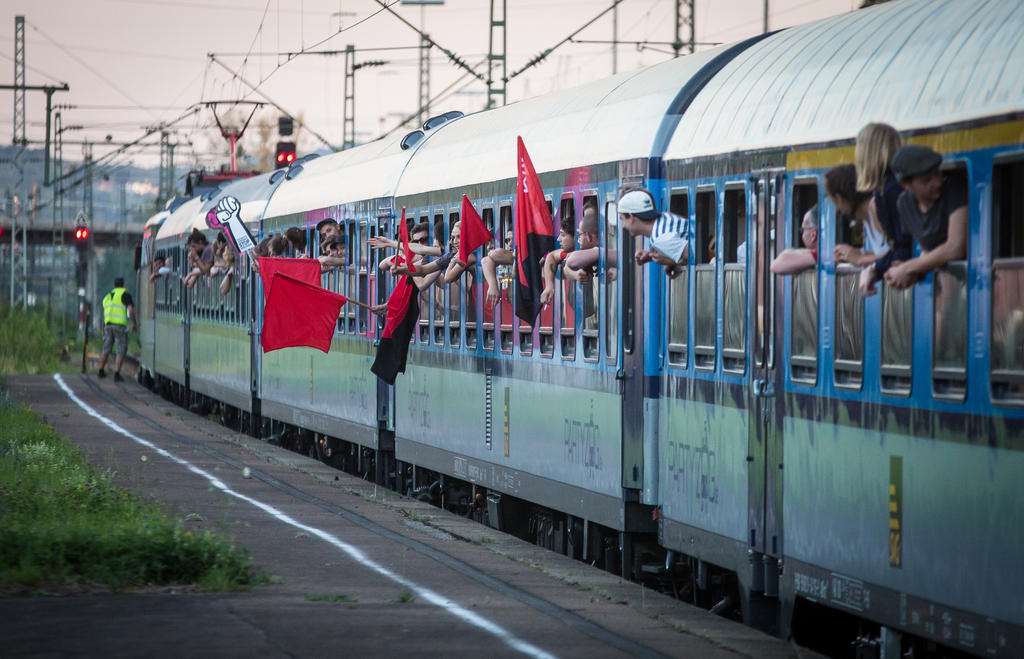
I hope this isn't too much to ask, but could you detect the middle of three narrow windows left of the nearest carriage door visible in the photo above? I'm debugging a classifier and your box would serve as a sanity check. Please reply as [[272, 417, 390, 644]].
[[691, 188, 718, 369]]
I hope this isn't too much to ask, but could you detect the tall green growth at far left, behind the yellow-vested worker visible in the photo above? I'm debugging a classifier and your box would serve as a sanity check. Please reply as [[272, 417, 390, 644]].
[[0, 303, 75, 375]]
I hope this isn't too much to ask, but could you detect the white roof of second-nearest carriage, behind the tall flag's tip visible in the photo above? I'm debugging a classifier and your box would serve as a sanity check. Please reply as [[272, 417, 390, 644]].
[[395, 47, 726, 195]]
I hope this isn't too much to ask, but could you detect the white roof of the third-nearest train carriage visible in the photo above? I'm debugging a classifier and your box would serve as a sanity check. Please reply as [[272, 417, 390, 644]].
[[266, 135, 417, 223]]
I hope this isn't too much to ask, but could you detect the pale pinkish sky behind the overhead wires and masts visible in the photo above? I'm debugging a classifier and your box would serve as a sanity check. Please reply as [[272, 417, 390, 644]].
[[0, 0, 860, 168]]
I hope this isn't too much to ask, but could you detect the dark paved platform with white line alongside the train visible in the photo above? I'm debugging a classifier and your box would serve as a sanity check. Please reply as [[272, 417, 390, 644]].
[[0, 375, 814, 657]]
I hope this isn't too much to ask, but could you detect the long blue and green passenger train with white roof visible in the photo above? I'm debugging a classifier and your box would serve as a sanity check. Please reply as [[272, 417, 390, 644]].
[[136, 0, 1024, 657]]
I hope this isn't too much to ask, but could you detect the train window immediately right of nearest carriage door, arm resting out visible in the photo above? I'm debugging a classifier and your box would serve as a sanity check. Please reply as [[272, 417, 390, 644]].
[[790, 179, 820, 385]]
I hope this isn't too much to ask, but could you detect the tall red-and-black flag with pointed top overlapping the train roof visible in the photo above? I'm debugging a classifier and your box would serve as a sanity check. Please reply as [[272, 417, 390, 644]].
[[515, 137, 555, 324]]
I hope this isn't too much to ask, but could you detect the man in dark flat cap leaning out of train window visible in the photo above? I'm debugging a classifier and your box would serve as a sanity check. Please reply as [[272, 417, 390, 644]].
[[886, 144, 968, 289]]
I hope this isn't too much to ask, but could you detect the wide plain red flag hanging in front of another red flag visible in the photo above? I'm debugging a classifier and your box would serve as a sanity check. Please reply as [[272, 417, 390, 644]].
[[260, 272, 348, 352]]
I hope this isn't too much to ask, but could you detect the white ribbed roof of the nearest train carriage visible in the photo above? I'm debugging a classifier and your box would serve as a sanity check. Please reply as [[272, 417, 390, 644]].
[[666, 0, 1024, 159]]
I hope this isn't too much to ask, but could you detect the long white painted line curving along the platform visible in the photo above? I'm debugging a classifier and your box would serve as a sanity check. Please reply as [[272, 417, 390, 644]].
[[53, 374, 554, 659]]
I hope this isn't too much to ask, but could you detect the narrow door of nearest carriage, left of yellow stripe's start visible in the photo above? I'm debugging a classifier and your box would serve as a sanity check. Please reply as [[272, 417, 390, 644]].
[[746, 169, 785, 597]]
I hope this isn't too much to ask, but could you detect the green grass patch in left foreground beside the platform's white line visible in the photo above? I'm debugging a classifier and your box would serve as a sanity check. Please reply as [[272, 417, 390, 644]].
[[0, 395, 266, 591]]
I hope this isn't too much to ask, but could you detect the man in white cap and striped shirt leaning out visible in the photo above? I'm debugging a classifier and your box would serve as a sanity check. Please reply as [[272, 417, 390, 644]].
[[618, 188, 690, 279]]
